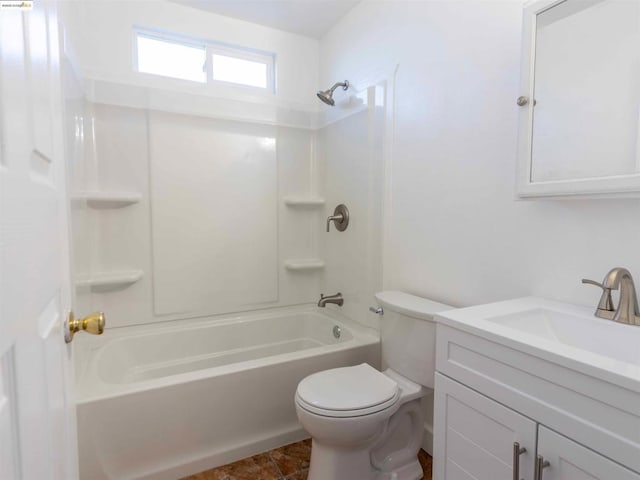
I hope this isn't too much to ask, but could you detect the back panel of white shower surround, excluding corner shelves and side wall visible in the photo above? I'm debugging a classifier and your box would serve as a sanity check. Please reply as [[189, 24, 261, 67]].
[[79, 105, 332, 327]]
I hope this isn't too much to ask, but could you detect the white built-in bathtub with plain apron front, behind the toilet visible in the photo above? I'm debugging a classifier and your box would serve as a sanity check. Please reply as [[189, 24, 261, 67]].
[[76, 309, 380, 480]]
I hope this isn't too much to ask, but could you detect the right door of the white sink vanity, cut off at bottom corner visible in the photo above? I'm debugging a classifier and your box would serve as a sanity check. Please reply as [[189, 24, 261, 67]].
[[538, 426, 640, 480]]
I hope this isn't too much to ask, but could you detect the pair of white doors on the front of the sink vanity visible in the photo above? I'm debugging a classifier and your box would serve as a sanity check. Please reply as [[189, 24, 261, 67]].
[[434, 374, 640, 480]]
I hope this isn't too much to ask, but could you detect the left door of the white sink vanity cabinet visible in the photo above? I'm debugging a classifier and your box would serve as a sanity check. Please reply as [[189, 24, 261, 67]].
[[433, 373, 536, 480]]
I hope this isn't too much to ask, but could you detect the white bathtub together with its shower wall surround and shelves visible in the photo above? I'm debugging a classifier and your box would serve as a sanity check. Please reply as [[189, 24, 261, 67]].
[[65, 7, 388, 480]]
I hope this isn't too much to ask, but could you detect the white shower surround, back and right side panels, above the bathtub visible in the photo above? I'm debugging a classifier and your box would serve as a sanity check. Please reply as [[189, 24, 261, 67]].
[[72, 92, 384, 327]]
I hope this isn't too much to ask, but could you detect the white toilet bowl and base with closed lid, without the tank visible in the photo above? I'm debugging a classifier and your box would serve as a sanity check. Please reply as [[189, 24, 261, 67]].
[[296, 363, 429, 480]]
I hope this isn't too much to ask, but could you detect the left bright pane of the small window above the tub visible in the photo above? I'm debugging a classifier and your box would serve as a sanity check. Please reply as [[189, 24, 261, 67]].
[[138, 35, 207, 83]]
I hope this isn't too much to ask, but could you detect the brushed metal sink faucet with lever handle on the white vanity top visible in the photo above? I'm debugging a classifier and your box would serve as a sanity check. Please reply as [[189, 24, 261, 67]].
[[582, 267, 640, 325]]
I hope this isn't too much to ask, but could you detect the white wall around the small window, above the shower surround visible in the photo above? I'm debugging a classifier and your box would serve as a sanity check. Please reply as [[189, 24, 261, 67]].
[[68, 0, 318, 111]]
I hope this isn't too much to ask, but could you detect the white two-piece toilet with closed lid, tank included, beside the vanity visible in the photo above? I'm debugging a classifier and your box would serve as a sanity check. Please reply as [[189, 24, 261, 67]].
[[295, 292, 453, 480]]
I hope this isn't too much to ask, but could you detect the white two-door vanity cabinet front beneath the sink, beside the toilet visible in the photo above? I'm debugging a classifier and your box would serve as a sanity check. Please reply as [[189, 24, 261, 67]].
[[433, 309, 640, 480]]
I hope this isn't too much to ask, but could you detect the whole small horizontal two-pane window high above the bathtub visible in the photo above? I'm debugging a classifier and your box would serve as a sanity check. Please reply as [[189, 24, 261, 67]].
[[135, 29, 275, 93]]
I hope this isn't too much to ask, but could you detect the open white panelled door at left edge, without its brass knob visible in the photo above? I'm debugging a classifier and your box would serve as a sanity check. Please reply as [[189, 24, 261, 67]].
[[0, 0, 78, 480]]
